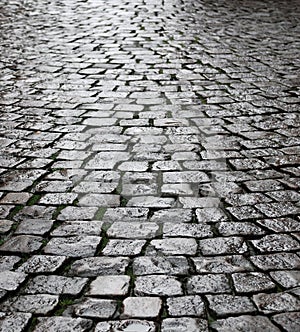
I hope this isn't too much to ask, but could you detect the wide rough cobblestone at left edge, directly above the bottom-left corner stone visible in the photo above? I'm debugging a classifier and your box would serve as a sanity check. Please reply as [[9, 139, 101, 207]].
[[0, 294, 59, 315]]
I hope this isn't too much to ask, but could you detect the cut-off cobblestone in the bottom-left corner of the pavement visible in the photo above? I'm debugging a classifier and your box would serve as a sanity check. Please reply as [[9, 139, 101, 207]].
[[0, 312, 32, 332]]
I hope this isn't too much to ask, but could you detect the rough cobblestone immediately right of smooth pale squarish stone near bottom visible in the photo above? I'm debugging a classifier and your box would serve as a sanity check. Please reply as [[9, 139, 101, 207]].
[[167, 295, 205, 317]]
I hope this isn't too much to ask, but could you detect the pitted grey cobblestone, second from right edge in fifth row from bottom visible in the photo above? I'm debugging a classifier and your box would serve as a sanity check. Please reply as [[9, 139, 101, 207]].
[[199, 236, 248, 255]]
